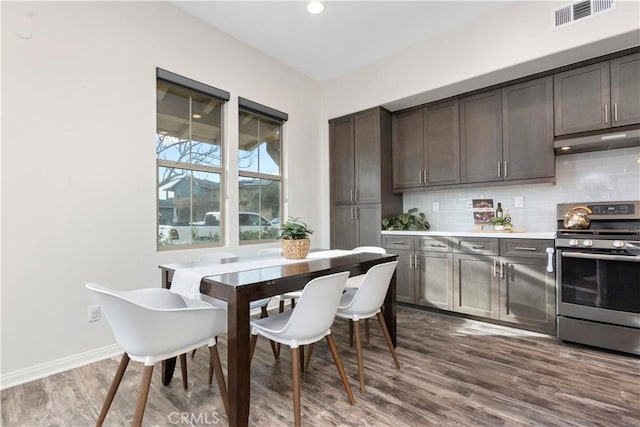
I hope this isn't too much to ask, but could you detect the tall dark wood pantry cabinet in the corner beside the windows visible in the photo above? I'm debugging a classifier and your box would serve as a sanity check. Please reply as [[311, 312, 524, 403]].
[[329, 108, 402, 249]]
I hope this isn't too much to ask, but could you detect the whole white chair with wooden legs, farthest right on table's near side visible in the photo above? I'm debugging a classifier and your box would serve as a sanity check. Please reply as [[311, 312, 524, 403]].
[[336, 261, 400, 393]]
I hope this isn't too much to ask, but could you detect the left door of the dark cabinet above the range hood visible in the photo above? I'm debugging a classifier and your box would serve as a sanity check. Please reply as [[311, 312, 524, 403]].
[[553, 61, 611, 135]]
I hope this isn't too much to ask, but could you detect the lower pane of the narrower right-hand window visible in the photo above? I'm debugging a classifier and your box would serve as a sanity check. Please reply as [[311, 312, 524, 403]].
[[238, 176, 280, 241]]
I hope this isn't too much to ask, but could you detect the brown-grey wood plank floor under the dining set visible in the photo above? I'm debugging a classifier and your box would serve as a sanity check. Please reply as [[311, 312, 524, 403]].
[[2, 307, 640, 427]]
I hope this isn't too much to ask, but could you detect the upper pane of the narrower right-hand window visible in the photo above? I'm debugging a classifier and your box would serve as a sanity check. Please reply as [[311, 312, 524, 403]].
[[238, 111, 282, 175]]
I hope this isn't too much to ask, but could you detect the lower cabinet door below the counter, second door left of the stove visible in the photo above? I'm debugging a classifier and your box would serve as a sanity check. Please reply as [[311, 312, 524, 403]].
[[453, 254, 500, 319]]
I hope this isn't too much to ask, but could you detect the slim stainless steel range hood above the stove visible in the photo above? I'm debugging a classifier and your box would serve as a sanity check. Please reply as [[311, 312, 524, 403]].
[[553, 129, 640, 155]]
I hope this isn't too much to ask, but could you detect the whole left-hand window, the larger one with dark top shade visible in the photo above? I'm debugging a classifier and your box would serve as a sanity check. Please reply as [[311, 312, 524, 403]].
[[156, 69, 229, 249]]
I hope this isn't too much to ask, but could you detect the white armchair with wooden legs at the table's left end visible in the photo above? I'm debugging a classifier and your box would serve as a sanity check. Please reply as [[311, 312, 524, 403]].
[[85, 283, 229, 426]]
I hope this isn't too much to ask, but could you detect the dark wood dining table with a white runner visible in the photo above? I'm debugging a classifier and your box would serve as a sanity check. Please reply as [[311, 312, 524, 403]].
[[159, 250, 397, 426]]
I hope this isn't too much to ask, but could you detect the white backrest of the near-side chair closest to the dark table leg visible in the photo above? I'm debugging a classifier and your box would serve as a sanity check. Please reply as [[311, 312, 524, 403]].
[[272, 271, 349, 340]]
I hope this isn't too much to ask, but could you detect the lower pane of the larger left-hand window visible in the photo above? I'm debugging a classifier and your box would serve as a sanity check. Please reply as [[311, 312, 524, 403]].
[[158, 167, 221, 246]]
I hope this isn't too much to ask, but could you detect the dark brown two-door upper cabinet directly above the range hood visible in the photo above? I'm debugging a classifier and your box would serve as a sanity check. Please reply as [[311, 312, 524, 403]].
[[554, 54, 640, 135]]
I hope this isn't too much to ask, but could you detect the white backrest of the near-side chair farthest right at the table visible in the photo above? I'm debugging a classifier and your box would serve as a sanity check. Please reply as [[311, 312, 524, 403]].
[[340, 261, 398, 313]]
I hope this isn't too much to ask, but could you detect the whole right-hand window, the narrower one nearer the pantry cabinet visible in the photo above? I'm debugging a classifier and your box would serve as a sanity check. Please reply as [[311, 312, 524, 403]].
[[238, 98, 288, 243]]
